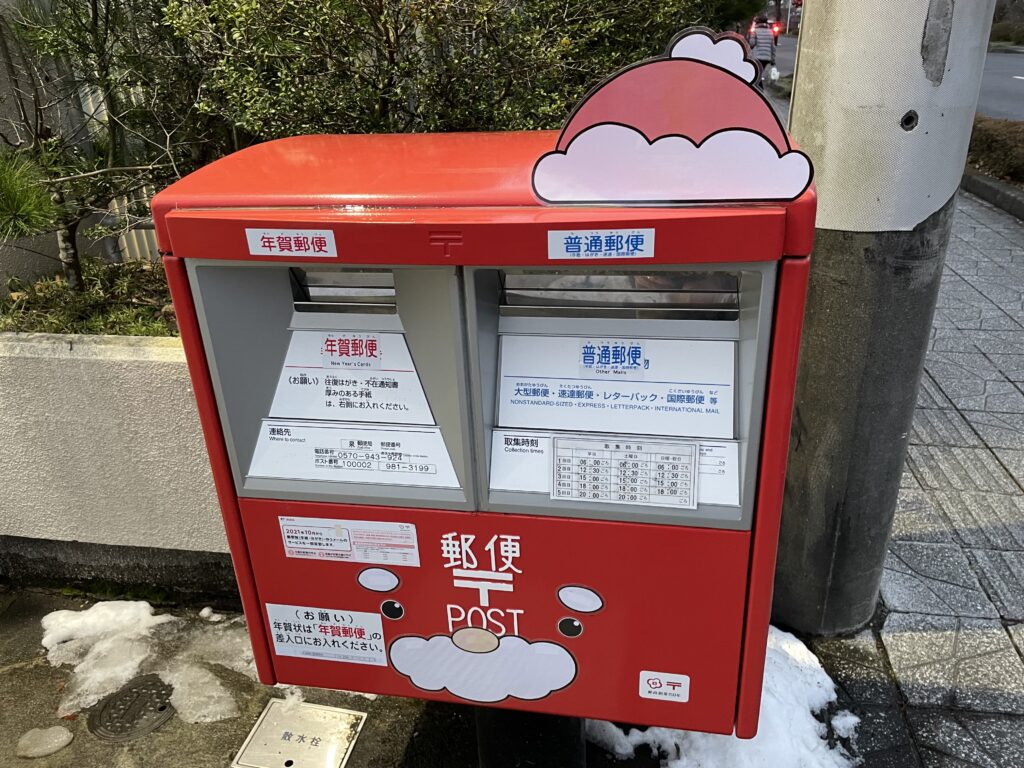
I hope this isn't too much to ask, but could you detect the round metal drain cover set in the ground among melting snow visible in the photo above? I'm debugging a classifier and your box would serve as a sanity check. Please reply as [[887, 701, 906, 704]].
[[87, 675, 174, 743]]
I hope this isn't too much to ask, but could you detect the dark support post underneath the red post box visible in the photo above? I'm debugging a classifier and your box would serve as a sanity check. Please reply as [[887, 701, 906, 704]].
[[476, 707, 587, 768]]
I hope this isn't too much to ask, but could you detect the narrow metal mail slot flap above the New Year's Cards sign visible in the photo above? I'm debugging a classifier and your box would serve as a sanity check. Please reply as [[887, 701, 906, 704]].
[[291, 267, 395, 314]]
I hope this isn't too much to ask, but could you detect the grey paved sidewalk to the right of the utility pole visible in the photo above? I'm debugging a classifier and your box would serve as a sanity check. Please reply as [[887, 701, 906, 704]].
[[812, 194, 1024, 768]]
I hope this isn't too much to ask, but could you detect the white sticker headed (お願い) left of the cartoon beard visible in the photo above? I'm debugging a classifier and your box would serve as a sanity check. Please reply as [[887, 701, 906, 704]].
[[266, 603, 387, 667]]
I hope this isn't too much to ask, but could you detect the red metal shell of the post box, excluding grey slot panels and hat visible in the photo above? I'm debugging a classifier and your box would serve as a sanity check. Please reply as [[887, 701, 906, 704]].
[[153, 132, 815, 737]]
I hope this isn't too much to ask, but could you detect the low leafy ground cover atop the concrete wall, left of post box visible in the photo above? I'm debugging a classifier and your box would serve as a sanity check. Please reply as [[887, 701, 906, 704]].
[[0, 256, 178, 336]]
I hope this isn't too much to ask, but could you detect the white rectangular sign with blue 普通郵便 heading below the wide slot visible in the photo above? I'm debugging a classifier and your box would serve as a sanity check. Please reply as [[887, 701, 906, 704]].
[[498, 335, 735, 439]]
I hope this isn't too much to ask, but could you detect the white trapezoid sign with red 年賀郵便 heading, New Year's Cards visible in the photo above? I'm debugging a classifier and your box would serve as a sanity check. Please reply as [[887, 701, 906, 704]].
[[270, 331, 434, 425]]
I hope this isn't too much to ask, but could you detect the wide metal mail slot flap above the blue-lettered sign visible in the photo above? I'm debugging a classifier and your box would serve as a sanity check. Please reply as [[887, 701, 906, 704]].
[[500, 270, 739, 321]]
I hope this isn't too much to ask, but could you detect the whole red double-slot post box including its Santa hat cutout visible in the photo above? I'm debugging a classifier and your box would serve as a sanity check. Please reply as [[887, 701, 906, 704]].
[[153, 30, 814, 737]]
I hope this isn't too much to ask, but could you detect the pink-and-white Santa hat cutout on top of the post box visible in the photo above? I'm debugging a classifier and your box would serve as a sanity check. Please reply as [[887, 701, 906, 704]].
[[534, 28, 813, 205]]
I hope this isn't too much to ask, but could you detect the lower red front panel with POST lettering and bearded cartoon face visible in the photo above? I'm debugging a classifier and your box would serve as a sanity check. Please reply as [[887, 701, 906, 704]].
[[240, 499, 750, 733]]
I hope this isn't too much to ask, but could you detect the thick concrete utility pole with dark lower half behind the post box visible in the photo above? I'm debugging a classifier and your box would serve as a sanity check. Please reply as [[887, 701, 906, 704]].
[[773, 0, 995, 634]]
